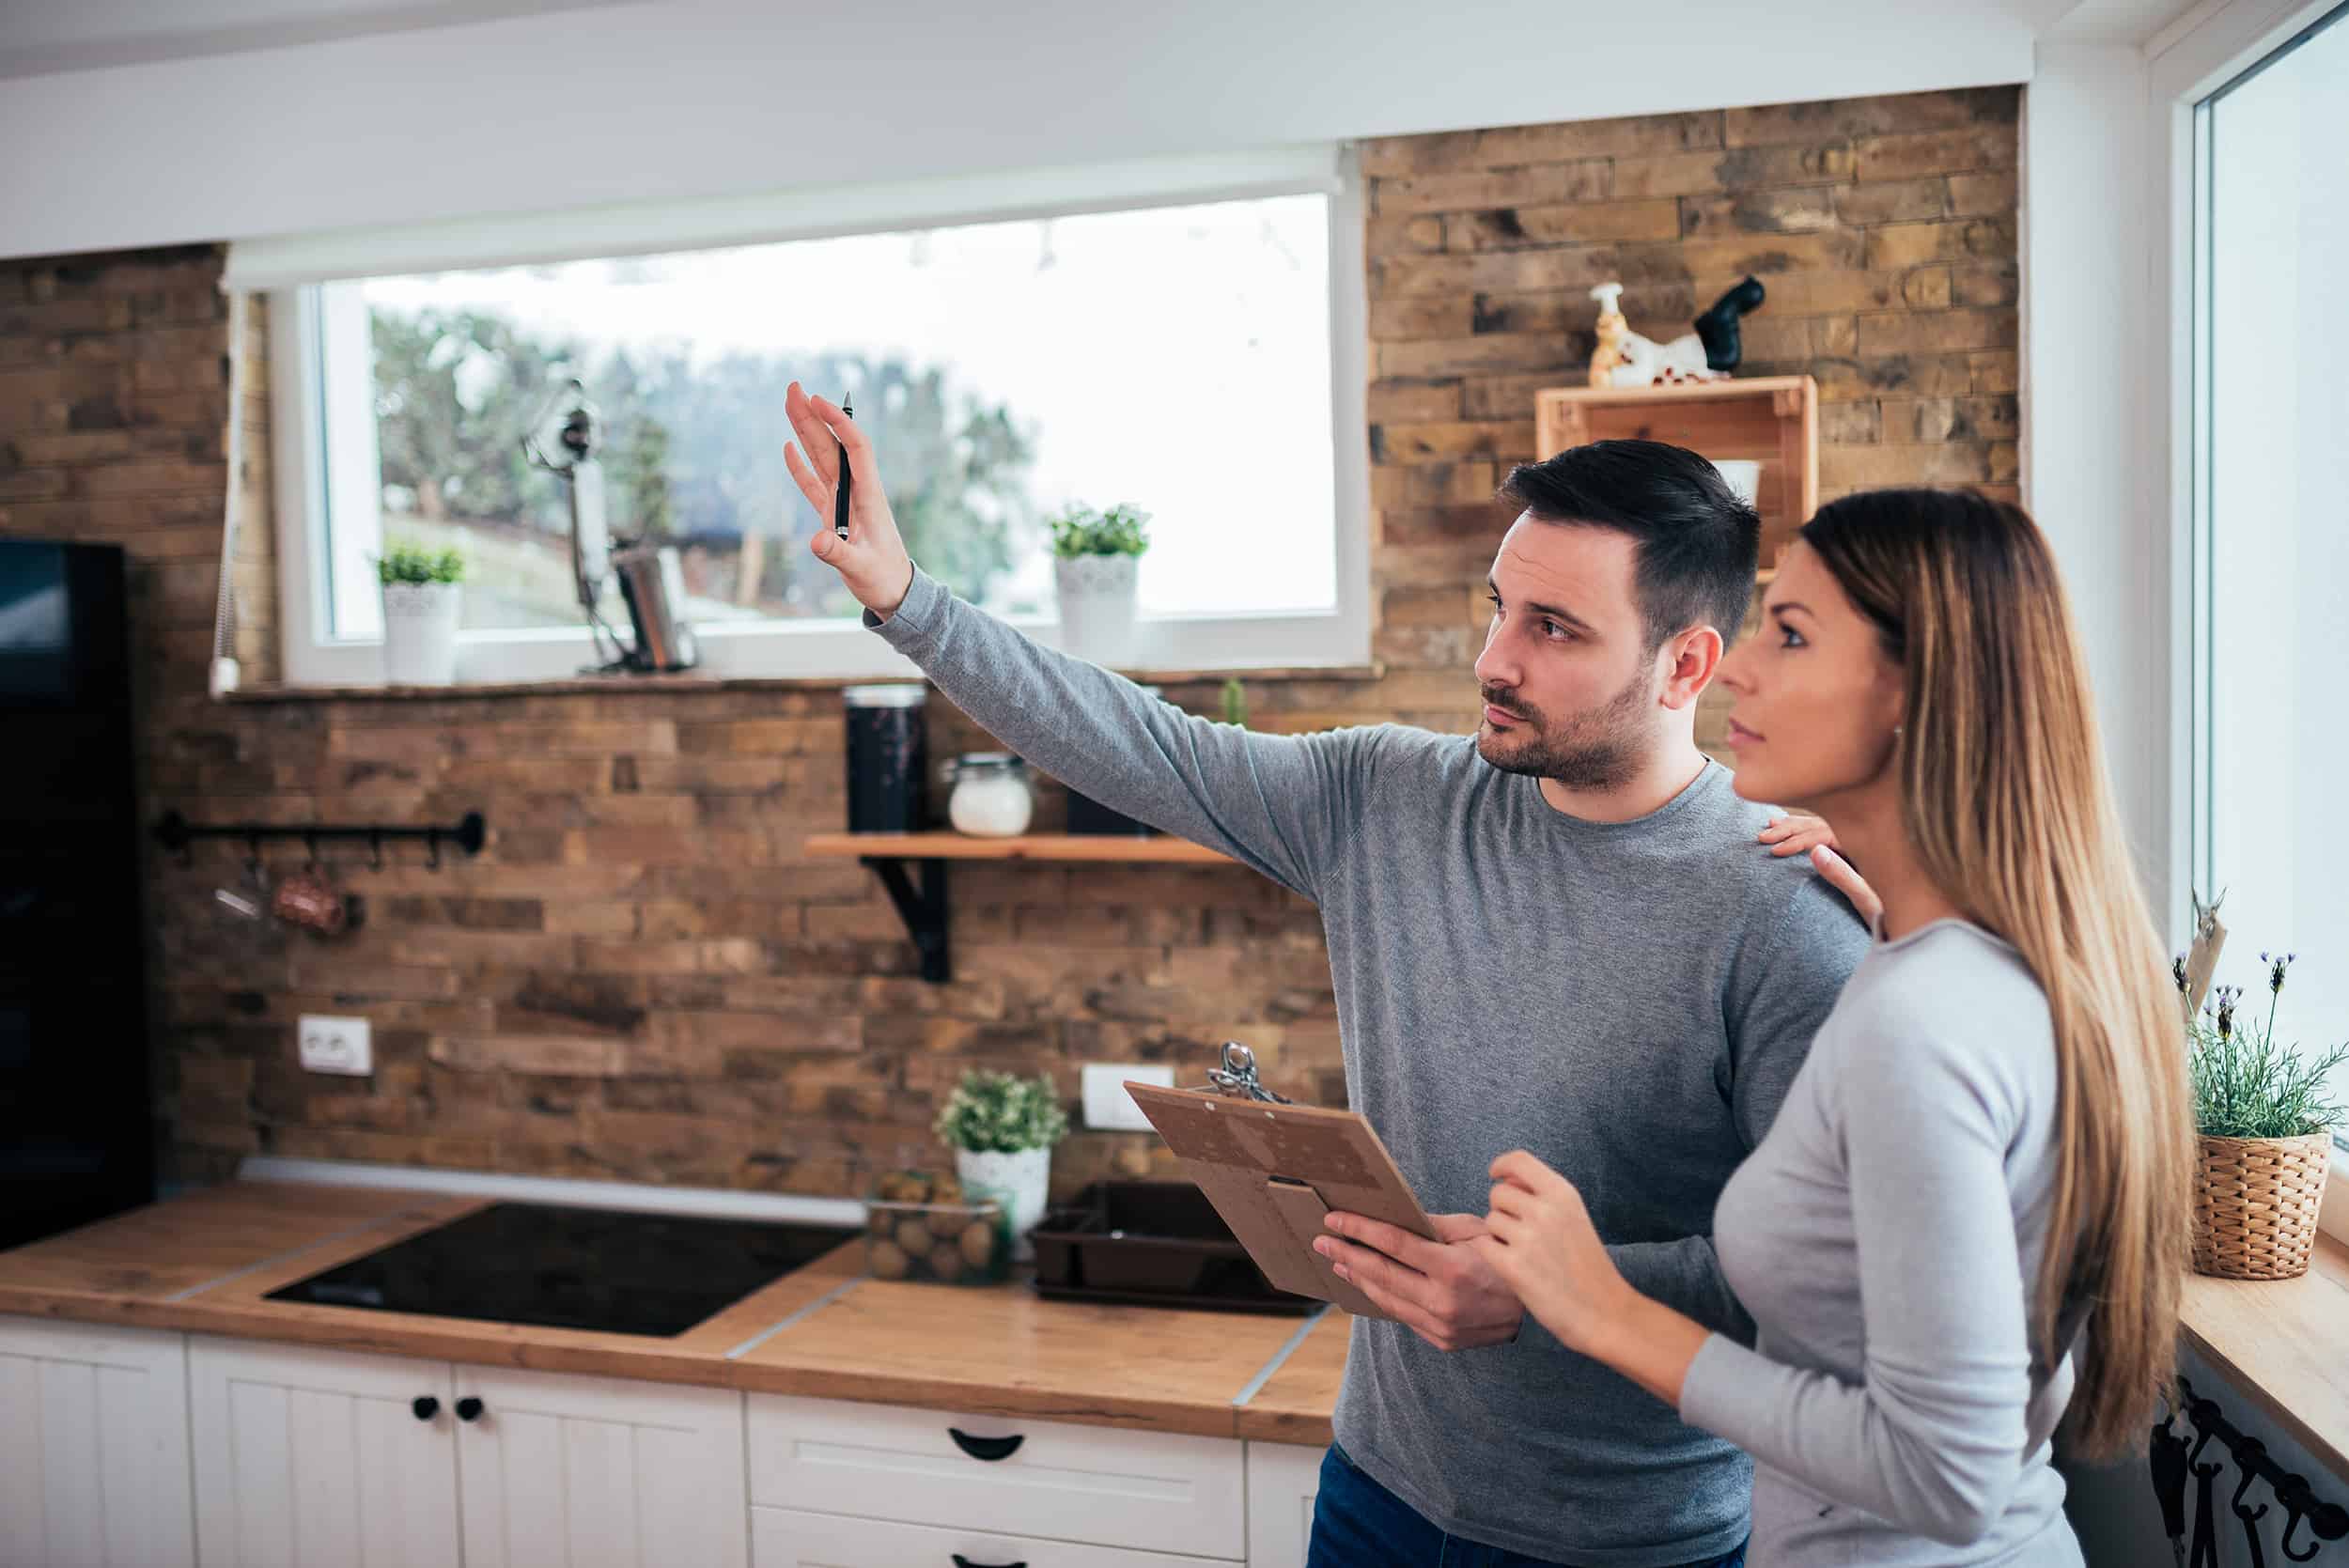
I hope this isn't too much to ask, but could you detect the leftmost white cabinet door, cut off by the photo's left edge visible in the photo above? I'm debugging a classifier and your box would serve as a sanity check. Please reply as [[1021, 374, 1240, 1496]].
[[0, 1317, 195, 1568]]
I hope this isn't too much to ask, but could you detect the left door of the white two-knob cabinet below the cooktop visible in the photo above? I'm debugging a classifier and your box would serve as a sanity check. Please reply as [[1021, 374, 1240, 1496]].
[[188, 1336, 459, 1568]]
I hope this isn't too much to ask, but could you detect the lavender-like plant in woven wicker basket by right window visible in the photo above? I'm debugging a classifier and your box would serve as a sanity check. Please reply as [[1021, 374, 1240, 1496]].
[[2173, 953, 2349, 1280]]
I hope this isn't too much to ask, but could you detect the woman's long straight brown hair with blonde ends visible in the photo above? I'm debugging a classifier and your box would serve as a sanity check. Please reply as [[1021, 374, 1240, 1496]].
[[1802, 490, 2194, 1455]]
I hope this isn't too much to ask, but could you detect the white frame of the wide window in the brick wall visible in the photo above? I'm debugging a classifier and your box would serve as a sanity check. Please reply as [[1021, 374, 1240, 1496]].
[[261, 146, 1372, 686]]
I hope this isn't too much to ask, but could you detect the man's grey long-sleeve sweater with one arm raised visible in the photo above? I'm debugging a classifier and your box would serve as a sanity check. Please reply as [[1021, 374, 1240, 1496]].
[[881, 573, 1868, 1568]]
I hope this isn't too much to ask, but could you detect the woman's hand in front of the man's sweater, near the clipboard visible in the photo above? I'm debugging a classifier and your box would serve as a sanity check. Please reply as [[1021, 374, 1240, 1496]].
[[1478, 1148, 1640, 1355]]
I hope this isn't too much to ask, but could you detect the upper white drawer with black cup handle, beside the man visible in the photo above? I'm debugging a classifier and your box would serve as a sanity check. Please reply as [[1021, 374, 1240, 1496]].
[[750, 1394, 1248, 1563]]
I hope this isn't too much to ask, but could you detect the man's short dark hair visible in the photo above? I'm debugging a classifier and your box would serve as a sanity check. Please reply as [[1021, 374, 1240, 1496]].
[[1501, 442, 1762, 650]]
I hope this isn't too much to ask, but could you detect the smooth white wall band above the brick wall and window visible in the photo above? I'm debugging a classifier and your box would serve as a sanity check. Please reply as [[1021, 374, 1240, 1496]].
[[0, 0, 2032, 256]]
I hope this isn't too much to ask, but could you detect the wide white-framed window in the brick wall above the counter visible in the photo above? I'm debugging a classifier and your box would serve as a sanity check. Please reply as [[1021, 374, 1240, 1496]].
[[228, 147, 1370, 686]]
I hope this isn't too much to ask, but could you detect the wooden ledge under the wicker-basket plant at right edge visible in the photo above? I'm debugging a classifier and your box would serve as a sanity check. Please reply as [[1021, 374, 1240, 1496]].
[[2185, 1237, 2349, 1479]]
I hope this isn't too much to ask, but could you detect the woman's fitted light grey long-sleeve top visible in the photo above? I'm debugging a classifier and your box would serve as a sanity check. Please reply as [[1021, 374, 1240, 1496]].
[[1680, 920, 2081, 1568]]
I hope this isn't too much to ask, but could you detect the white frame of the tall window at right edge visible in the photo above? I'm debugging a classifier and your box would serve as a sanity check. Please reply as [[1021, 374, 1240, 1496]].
[[2145, 0, 2349, 1242]]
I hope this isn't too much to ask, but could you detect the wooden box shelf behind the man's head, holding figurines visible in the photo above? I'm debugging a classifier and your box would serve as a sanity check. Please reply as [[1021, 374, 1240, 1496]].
[[1534, 376, 1818, 568]]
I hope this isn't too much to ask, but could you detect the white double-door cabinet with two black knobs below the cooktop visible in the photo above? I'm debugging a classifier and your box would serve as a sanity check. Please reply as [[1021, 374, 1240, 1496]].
[[188, 1338, 750, 1568]]
